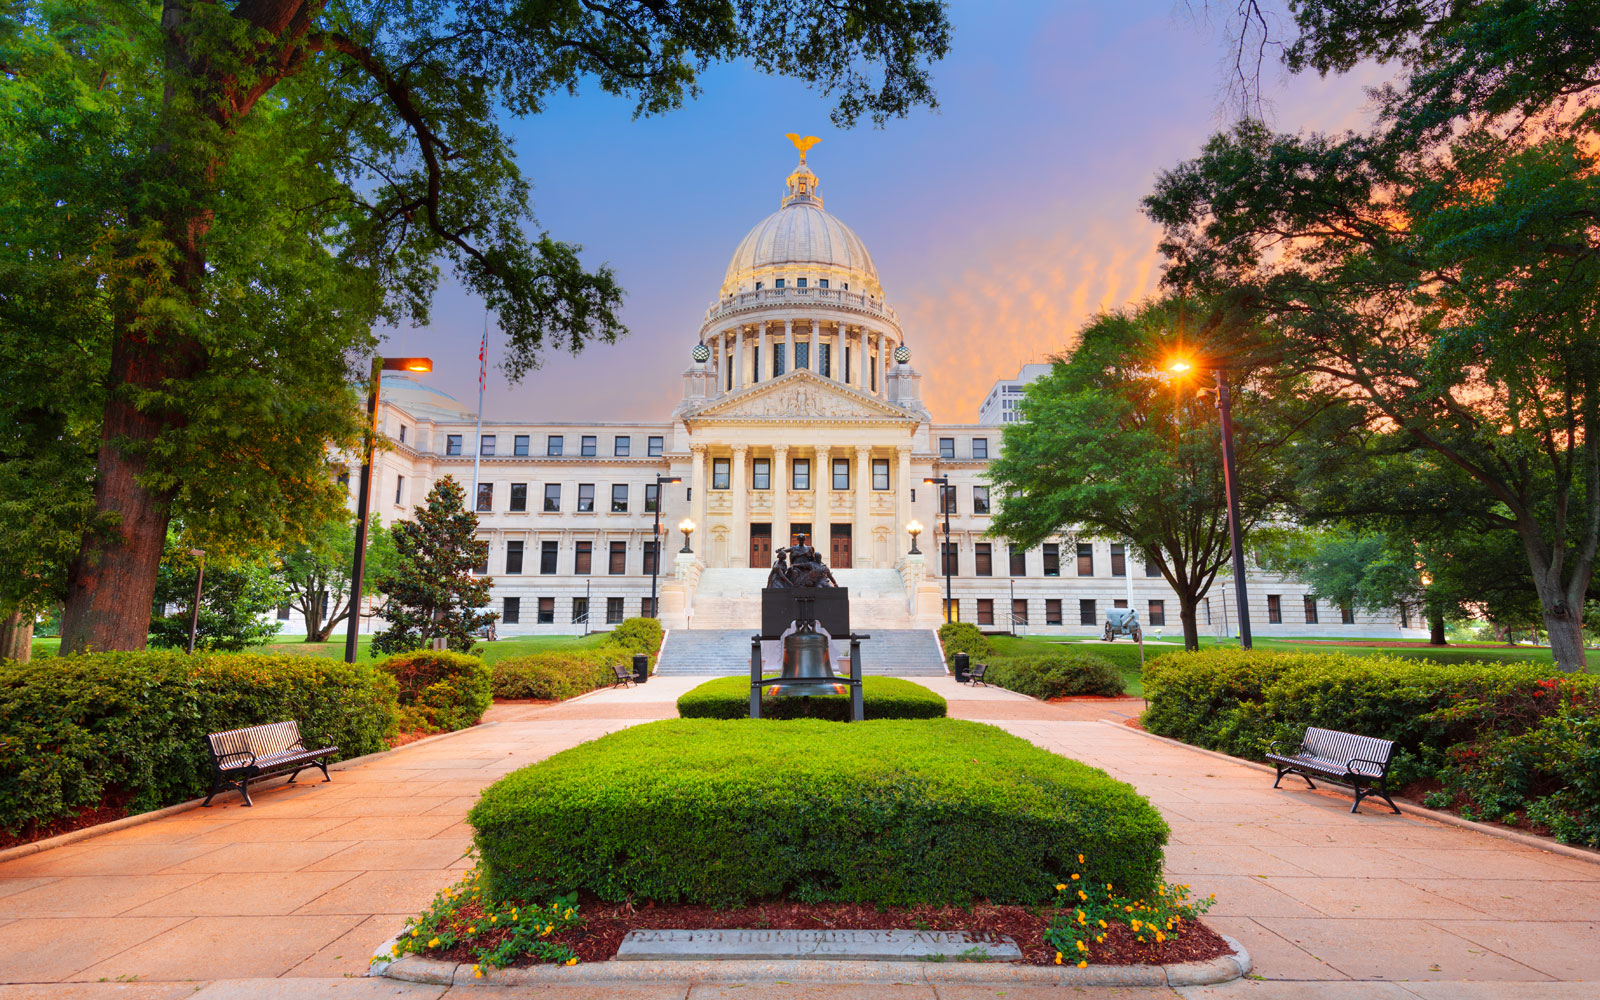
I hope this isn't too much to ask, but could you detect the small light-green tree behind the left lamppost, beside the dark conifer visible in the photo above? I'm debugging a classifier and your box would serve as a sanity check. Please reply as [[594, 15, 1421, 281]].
[[278, 514, 395, 642]]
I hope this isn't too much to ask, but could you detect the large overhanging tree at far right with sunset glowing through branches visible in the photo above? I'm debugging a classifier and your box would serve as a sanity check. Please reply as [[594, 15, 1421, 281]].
[[1146, 0, 1600, 670]]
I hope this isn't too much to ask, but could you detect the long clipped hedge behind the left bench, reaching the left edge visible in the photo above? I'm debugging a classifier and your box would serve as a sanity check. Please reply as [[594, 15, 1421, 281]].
[[0, 651, 397, 835]]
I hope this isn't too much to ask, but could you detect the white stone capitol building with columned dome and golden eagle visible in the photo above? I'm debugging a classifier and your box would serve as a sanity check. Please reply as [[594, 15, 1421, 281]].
[[344, 144, 1426, 651]]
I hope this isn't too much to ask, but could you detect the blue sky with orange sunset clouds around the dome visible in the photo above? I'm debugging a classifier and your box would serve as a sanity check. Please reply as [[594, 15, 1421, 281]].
[[381, 0, 1382, 422]]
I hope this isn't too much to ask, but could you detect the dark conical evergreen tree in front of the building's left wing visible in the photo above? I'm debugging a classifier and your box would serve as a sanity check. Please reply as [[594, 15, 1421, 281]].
[[373, 475, 499, 653]]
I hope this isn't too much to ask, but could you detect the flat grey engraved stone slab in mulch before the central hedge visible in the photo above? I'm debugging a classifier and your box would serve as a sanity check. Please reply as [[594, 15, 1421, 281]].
[[616, 930, 1022, 962]]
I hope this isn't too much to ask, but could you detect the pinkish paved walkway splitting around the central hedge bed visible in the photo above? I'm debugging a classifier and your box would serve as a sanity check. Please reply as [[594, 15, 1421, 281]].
[[0, 678, 1600, 1000]]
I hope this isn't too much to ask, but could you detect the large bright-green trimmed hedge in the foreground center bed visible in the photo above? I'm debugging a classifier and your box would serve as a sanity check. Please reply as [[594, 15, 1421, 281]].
[[467, 718, 1168, 906]]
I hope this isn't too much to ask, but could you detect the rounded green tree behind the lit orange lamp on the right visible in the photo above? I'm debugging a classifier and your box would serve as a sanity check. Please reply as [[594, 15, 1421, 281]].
[[989, 298, 1296, 650]]
